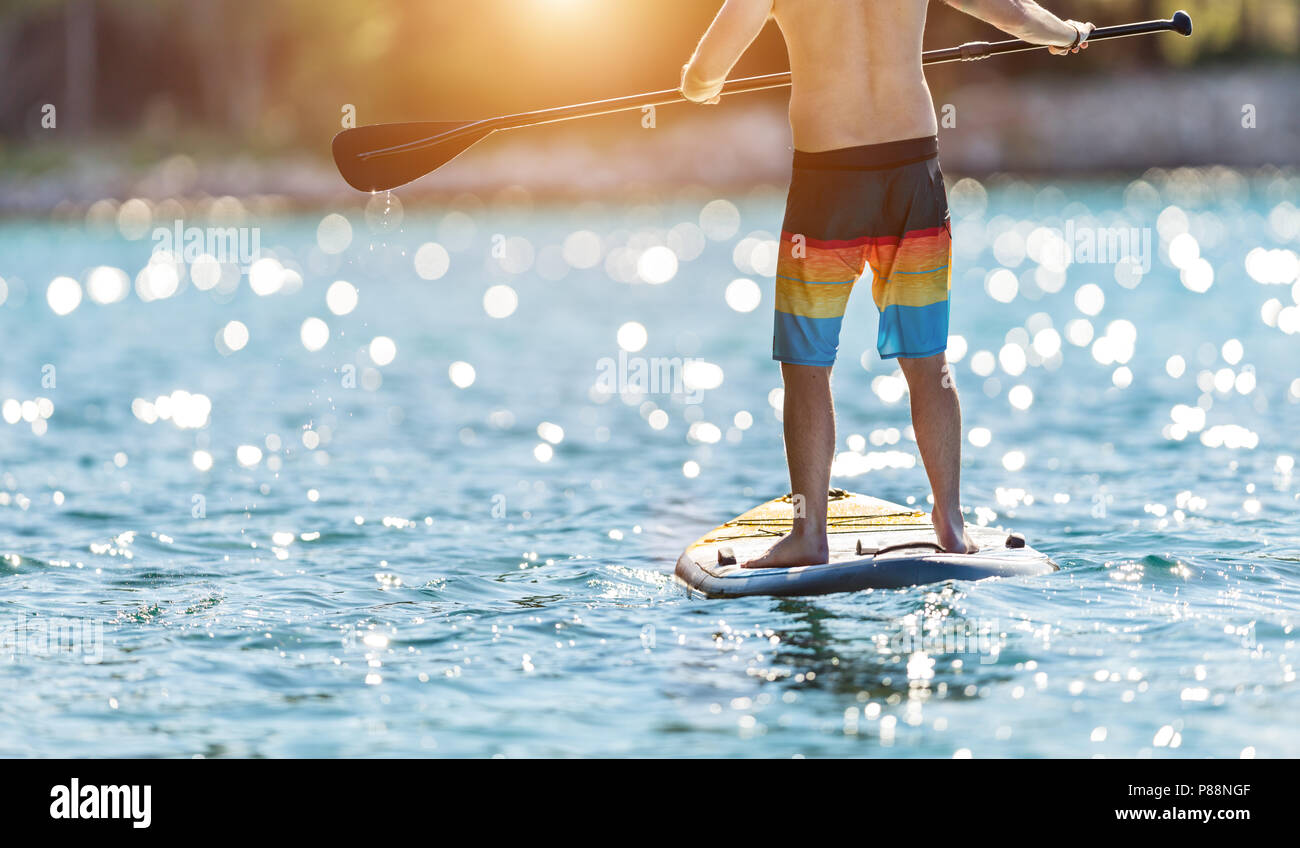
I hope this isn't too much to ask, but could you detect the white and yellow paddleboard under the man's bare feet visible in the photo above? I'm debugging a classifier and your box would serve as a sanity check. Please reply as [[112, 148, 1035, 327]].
[[676, 489, 1057, 598]]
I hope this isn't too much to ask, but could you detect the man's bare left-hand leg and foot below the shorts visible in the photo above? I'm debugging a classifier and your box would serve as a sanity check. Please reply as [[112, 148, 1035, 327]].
[[742, 363, 835, 568]]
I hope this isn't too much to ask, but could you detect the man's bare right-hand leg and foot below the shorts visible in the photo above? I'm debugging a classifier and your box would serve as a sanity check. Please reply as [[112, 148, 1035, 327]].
[[898, 354, 978, 554]]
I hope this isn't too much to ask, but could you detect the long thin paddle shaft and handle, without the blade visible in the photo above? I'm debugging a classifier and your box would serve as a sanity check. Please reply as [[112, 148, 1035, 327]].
[[360, 12, 1192, 159]]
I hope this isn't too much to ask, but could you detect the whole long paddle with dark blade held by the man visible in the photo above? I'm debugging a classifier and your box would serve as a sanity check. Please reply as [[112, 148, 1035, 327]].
[[333, 12, 1192, 191]]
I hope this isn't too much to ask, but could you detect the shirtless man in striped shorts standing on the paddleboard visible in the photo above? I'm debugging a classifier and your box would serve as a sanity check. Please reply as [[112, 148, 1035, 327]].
[[681, 0, 1093, 568]]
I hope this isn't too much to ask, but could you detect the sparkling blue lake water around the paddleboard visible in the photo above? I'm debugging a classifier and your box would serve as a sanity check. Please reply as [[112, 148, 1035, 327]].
[[0, 172, 1300, 757]]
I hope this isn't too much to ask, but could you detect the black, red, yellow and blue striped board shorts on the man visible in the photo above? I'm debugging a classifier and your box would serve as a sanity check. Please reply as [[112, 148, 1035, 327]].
[[772, 137, 952, 365]]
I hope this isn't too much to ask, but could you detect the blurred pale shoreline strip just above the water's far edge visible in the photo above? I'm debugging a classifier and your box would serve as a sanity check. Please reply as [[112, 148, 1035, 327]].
[[0, 66, 1300, 220]]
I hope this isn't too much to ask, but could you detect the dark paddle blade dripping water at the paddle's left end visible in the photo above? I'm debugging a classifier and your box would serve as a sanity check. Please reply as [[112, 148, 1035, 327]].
[[332, 121, 493, 191]]
